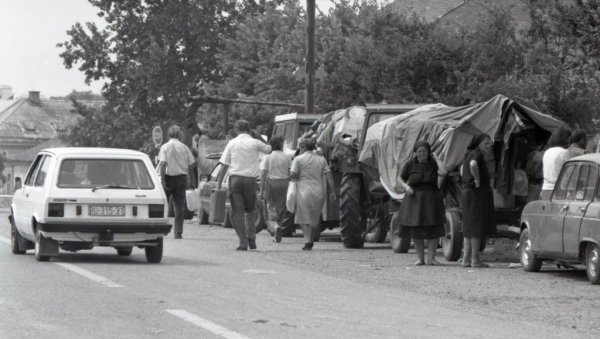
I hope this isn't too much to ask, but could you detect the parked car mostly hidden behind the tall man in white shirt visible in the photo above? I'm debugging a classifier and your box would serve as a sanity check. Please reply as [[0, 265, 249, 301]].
[[198, 163, 266, 233]]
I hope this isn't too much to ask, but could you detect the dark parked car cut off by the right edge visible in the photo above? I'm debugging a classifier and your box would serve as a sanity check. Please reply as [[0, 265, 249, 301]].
[[519, 154, 600, 284]]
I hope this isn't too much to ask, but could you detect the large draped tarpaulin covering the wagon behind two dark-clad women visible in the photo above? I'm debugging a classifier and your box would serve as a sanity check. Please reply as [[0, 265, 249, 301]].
[[359, 95, 566, 199]]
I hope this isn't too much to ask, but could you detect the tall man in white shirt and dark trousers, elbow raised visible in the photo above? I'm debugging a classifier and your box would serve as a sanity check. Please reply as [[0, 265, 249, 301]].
[[217, 120, 271, 251]]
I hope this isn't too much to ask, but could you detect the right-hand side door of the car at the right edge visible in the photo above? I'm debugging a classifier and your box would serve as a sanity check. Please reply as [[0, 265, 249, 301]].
[[563, 163, 598, 259]]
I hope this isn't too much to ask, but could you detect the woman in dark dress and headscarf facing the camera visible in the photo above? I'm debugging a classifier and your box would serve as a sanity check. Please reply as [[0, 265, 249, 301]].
[[398, 141, 444, 265]]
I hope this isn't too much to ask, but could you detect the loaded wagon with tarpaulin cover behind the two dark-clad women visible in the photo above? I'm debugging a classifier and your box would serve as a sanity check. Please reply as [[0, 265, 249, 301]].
[[359, 95, 567, 261]]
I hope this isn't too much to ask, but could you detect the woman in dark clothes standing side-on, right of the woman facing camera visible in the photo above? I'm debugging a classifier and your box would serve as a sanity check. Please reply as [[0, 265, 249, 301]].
[[461, 134, 496, 267]]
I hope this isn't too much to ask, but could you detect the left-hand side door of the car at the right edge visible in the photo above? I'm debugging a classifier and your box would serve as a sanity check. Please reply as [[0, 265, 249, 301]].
[[539, 163, 578, 256]]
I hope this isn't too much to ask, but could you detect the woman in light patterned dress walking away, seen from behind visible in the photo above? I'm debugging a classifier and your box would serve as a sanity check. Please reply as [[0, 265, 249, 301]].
[[290, 138, 335, 251]]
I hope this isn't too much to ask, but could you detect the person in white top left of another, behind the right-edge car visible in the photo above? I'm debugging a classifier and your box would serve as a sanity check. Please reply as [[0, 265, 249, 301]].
[[541, 127, 571, 200]]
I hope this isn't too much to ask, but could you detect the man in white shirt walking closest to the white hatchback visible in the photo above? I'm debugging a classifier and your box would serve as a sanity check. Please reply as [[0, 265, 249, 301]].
[[158, 125, 195, 239]]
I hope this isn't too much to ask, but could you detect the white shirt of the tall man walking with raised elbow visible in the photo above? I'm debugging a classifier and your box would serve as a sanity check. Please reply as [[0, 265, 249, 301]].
[[219, 133, 271, 178]]
